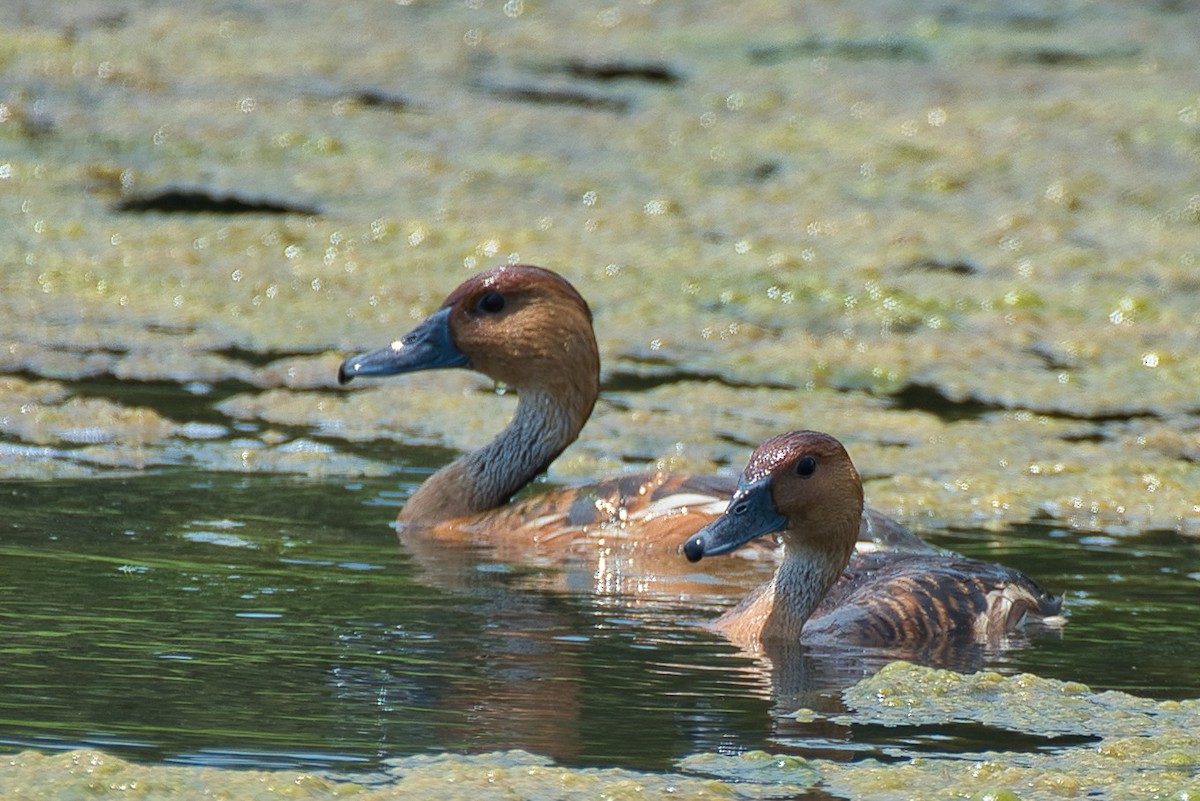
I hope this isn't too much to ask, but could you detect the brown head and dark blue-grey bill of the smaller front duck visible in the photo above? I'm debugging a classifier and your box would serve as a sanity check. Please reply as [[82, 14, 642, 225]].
[[683, 430, 863, 570]]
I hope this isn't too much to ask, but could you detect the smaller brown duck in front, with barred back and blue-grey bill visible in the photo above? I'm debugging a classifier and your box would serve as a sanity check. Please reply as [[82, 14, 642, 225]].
[[683, 430, 1063, 650]]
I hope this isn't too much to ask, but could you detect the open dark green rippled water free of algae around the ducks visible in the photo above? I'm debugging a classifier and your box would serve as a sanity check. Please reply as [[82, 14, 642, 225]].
[[0, 469, 1200, 770]]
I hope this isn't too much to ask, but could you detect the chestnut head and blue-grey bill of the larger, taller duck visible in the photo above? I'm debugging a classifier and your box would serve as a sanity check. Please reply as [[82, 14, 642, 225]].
[[337, 264, 600, 391]]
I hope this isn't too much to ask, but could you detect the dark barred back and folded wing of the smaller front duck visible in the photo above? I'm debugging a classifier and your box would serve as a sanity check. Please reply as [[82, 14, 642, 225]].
[[803, 553, 1062, 645]]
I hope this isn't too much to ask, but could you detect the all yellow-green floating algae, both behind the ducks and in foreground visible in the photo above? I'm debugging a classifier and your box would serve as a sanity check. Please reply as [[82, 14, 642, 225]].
[[0, 0, 1200, 801]]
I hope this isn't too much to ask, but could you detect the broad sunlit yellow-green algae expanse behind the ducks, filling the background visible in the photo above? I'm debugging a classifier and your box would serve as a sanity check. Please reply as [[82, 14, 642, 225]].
[[0, 4, 1200, 532]]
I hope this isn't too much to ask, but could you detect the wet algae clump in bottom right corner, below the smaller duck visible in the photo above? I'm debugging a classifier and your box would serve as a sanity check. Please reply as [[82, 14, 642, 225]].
[[821, 662, 1200, 801]]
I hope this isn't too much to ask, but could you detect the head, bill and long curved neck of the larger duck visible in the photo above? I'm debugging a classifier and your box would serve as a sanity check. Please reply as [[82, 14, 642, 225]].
[[337, 265, 600, 525]]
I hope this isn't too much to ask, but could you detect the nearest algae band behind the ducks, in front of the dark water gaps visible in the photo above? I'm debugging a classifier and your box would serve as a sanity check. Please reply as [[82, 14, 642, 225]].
[[221, 375, 1200, 534]]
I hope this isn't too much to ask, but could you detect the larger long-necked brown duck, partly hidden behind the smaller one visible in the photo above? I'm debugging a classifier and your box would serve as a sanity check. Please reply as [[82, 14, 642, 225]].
[[337, 264, 923, 585]]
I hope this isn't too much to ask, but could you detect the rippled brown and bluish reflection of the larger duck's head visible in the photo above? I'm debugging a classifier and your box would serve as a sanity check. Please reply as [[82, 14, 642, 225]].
[[330, 594, 590, 761]]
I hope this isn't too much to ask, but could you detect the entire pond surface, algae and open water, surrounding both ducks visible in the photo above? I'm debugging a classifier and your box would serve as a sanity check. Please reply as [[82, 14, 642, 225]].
[[0, 0, 1200, 801]]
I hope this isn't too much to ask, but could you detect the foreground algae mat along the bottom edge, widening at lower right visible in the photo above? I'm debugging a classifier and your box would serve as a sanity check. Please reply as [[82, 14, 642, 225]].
[[0, 662, 1200, 801]]
